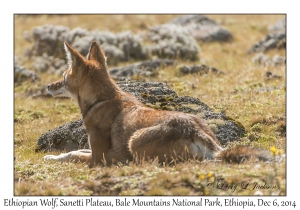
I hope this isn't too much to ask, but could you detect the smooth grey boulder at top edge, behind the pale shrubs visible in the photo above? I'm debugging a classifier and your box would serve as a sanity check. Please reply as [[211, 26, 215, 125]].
[[168, 15, 233, 42]]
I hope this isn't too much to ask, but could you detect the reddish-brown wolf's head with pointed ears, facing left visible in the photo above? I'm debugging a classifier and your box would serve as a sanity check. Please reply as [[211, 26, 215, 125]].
[[47, 41, 109, 102]]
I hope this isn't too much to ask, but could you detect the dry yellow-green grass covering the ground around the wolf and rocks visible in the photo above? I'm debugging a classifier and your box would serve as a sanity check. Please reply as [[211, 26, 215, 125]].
[[14, 15, 286, 195]]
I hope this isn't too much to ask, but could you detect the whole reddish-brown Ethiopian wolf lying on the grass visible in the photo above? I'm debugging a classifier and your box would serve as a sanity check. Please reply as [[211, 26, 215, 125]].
[[44, 42, 272, 166]]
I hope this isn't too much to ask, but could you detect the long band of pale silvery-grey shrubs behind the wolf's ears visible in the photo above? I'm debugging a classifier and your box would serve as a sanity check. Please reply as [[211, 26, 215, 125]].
[[24, 25, 200, 74]]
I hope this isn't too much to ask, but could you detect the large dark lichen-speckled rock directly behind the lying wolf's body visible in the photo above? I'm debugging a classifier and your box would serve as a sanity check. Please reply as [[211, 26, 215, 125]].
[[35, 80, 245, 151]]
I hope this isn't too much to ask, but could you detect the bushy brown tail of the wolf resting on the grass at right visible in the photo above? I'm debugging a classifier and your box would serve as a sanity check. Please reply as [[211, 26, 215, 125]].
[[216, 146, 285, 163]]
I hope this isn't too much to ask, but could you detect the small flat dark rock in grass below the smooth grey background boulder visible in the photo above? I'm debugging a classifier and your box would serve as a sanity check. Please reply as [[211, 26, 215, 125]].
[[179, 64, 225, 75]]
